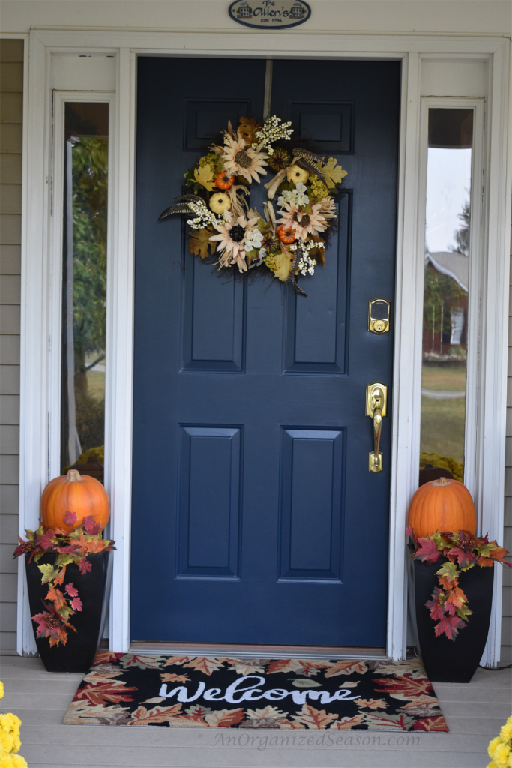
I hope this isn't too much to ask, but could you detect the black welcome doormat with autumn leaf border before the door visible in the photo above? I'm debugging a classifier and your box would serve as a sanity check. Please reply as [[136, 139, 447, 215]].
[[64, 651, 448, 731]]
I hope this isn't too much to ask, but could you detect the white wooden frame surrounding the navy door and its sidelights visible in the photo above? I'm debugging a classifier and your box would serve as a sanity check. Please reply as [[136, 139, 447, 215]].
[[17, 30, 511, 664]]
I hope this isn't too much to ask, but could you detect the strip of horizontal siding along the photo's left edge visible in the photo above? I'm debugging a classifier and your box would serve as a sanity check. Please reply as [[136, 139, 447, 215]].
[[0, 40, 23, 654]]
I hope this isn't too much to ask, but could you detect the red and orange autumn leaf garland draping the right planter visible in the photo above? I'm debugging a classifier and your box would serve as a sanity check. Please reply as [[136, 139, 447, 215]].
[[406, 526, 512, 640]]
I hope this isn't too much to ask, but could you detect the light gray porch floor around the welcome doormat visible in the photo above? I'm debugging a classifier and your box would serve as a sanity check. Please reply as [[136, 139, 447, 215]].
[[0, 656, 512, 768]]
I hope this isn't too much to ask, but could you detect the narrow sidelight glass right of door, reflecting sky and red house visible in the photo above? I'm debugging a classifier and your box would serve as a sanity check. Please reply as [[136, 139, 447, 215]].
[[420, 109, 473, 484]]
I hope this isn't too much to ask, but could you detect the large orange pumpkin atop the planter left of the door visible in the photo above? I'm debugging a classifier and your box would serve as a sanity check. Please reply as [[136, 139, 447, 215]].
[[41, 469, 110, 532]]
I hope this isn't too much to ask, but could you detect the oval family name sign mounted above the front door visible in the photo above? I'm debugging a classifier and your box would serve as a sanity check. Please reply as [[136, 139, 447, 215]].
[[229, 0, 311, 29]]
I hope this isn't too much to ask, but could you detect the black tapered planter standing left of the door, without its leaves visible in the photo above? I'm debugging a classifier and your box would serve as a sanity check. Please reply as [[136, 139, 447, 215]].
[[25, 552, 110, 672]]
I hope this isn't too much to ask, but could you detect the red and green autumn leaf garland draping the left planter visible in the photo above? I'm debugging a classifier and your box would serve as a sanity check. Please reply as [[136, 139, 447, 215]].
[[14, 512, 115, 647]]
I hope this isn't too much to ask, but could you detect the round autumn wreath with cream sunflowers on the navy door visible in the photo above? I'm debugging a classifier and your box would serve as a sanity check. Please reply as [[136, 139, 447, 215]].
[[159, 115, 347, 296]]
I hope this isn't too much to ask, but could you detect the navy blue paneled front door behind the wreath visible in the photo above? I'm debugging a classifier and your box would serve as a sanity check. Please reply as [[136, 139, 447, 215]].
[[131, 58, 400, 646]]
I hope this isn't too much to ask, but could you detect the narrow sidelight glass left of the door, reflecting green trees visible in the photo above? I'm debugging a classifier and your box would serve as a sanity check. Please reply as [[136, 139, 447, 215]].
[[61, 103, 109, 480]]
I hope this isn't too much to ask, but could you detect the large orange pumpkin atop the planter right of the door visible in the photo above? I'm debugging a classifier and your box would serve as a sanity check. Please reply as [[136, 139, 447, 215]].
[[408, 477, 476, 537]]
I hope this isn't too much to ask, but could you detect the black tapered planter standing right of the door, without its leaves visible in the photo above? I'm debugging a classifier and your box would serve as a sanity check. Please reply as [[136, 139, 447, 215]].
[[413, 558, 494, 683]]
